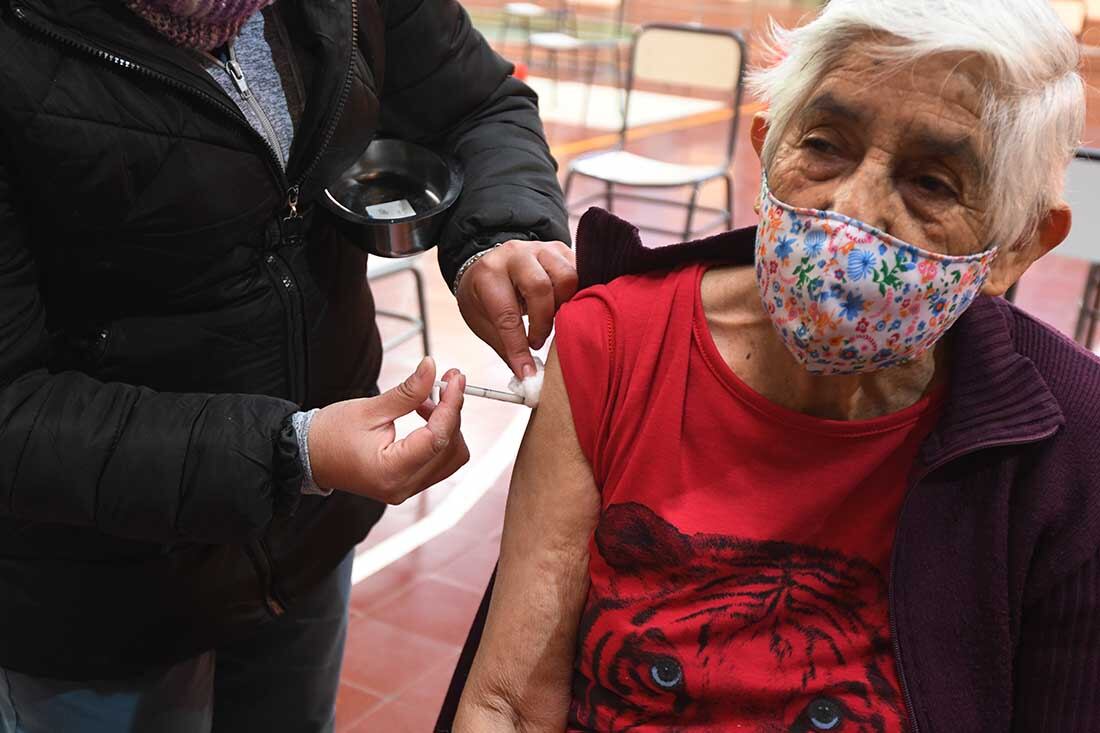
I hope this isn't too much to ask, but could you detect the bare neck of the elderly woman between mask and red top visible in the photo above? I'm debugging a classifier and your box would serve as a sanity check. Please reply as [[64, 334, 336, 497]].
[[702, 267, 949, 420]]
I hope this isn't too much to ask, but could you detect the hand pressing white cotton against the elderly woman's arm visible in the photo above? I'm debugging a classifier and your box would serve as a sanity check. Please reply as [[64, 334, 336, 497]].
[[458, 241, 576, 379]]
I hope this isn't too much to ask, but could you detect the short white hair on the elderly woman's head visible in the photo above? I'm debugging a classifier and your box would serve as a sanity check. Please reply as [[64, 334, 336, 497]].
[[749, 0, 1085, 245]]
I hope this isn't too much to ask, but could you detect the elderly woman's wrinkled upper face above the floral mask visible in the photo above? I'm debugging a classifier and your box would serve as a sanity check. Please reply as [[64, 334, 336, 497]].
[[768, 44, 991, 255]]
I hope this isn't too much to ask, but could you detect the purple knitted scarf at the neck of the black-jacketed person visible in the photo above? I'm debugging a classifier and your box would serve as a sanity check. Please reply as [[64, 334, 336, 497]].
[[125, 0, 275, 51]]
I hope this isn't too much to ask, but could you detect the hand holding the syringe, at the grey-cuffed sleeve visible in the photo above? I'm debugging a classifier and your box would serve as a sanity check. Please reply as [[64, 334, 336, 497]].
[[309, 357, 470, 504]]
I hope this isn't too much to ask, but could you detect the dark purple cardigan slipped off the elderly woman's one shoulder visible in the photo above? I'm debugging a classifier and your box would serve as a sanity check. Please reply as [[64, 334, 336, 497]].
[[576, 209, 1100, 733]]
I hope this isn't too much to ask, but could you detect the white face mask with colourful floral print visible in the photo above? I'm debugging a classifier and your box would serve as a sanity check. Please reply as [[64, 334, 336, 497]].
[[756, 177, 997, 374]]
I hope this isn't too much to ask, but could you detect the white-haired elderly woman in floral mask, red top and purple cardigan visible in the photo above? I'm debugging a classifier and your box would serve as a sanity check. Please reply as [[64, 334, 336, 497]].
[[457, 0, 1100, 733]]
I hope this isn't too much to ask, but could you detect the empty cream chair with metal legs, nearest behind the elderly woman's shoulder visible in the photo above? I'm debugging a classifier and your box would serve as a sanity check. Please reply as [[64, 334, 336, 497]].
[[564, 24, 747, 240]]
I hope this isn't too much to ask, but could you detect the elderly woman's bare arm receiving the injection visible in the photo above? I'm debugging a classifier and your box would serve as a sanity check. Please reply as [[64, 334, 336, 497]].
[[455, 343, 600, 733]]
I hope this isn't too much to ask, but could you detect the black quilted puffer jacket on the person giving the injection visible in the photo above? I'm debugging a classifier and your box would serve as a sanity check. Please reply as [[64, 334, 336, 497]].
[[0, 0, 567, 678]]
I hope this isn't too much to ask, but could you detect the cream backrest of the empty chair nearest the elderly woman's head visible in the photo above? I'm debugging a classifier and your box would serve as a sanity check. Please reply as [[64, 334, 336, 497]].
[[619, 23, 748, 165]]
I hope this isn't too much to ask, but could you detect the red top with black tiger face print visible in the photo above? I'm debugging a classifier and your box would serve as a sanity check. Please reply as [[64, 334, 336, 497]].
[[557, 265, 943, 733]]
